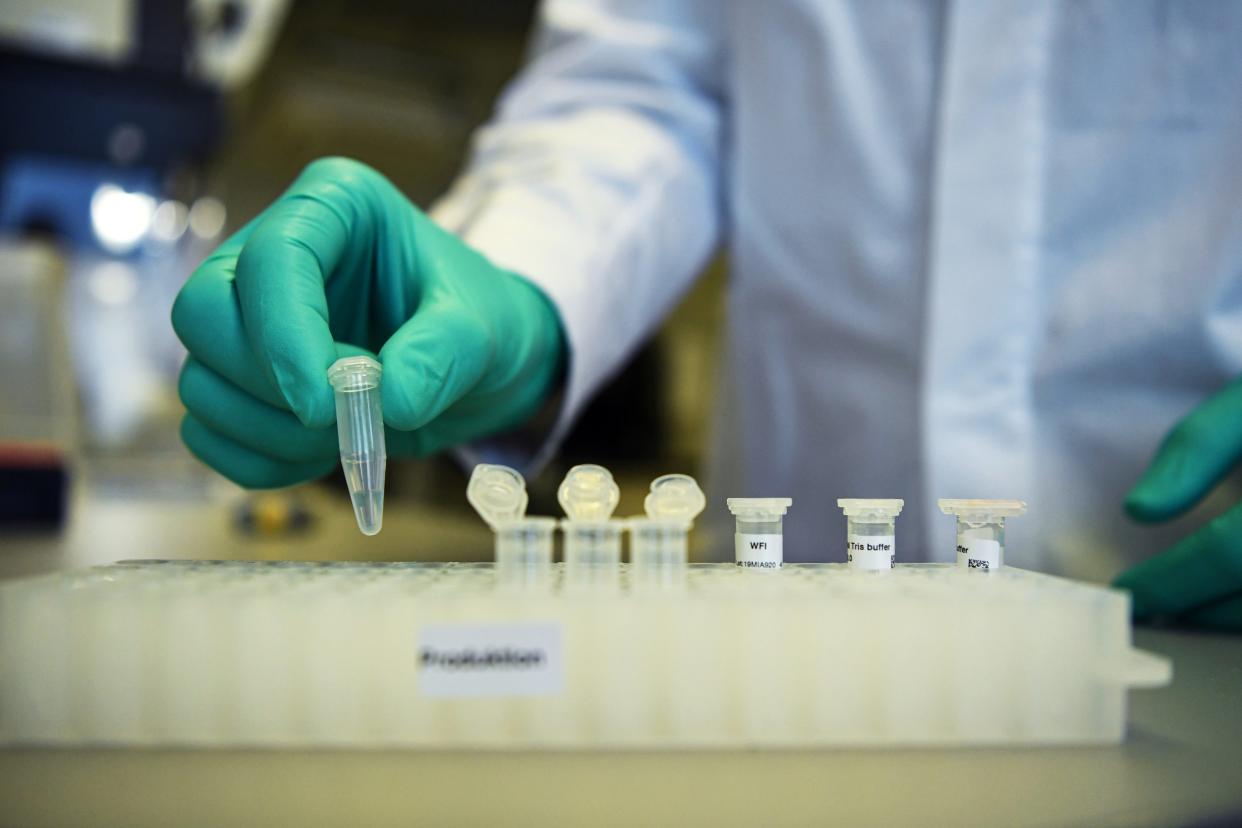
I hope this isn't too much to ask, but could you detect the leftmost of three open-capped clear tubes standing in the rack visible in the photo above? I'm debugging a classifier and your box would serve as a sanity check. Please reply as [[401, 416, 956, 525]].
[[466, 463, 556, 583]]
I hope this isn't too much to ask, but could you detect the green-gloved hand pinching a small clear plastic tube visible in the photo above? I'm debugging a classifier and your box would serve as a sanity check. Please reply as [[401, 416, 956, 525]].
[[173, 159, 564, 488]]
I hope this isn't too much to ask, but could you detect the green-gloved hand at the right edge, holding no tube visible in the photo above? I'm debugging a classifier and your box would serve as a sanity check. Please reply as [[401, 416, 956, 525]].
[[1114, 380, 1242, 629]]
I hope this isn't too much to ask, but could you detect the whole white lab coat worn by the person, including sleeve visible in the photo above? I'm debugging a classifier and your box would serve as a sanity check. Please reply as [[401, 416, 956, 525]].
[[435, 0, 1242, 577]]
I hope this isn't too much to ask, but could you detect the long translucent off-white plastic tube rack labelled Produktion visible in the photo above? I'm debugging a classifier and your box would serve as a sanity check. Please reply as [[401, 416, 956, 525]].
[[0, 561, 1170, 750]]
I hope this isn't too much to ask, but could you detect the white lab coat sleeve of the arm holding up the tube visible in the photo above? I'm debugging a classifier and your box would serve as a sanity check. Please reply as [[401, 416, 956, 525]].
[[431, 0, 724, 470]]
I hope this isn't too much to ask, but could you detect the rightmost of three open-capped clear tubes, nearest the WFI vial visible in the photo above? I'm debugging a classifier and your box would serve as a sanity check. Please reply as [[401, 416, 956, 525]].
[[630, 474, 707, 583]]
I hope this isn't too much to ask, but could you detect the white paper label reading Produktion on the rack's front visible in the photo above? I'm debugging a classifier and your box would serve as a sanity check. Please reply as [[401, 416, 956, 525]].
[[416, 623, 565, 699]]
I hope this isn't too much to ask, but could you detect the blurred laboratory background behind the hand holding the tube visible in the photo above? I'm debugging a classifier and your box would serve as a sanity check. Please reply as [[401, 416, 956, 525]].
[[0, 0, 724, 577]]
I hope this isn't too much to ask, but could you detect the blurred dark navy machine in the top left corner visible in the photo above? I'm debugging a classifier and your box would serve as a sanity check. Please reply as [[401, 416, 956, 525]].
[[0, 0, 289, 198]]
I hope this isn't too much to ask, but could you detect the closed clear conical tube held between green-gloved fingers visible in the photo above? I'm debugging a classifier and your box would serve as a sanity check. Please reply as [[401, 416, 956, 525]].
[[328, 356, 388, 535]]
